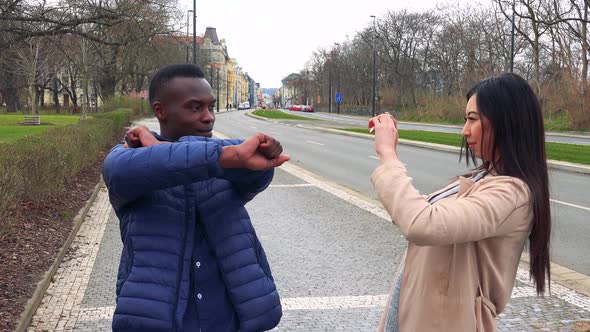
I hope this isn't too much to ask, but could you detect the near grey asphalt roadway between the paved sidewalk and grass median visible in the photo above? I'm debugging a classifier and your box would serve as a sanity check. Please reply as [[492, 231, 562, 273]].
[[142, 111, 590, 275]]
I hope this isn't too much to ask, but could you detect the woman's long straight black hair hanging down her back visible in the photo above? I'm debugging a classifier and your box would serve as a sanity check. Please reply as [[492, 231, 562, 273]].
[[461, 74, 551, 294]]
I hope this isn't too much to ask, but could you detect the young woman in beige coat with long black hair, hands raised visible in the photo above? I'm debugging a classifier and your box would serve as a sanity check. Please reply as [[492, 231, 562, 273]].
[[369, 74, 551, 332]]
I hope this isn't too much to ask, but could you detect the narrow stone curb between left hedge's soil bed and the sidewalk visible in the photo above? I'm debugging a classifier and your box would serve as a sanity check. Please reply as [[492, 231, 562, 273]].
[[15, 176, 104, 332]]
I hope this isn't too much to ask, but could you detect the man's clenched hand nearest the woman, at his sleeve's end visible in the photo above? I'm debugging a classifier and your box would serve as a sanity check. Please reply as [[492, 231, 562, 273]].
[[219, 133, 291, 170]]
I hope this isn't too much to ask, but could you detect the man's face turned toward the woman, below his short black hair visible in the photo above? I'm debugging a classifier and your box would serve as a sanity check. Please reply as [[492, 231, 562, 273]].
[[152, 77, 215, 140]]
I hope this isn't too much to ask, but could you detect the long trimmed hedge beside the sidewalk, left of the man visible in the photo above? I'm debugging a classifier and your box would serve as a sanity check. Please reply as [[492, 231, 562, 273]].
[[0, 111, 131, 237]]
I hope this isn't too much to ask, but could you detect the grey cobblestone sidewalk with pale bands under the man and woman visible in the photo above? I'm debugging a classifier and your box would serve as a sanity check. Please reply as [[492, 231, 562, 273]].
[[28, 165, 590, 331]]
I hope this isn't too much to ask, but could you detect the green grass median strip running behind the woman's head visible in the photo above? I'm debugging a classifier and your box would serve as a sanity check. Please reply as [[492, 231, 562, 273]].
[[340, 128, 590, 165]]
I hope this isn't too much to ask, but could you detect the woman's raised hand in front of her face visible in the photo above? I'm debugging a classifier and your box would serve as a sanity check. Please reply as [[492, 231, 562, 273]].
[[369, 113, 399, 163]]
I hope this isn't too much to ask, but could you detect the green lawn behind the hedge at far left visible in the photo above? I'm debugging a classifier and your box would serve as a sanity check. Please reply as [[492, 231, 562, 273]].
[[0, 114, 85, 143]]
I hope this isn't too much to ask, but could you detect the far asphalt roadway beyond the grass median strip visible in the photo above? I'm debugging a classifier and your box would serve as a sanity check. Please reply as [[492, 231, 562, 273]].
[[285, 110, 590, 145]]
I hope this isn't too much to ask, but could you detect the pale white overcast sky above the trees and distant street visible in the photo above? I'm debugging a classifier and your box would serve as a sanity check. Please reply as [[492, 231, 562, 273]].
[[178, 0, 458, 88]]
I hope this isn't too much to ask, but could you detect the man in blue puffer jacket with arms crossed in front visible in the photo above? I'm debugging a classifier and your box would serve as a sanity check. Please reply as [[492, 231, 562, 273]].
[[103, 64, 289, 332]]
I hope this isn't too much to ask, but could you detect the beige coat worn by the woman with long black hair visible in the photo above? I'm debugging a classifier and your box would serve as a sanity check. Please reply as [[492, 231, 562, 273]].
[[371, 161, 533, 332]]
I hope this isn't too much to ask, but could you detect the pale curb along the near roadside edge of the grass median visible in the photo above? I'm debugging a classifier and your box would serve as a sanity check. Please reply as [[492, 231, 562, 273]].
[[300, 126, 590, 174]]
